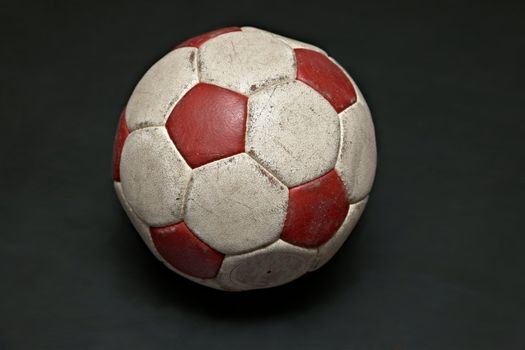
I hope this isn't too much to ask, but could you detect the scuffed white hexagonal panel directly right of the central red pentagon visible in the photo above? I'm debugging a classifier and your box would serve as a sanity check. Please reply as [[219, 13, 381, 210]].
[[246, 81, 340, 187]]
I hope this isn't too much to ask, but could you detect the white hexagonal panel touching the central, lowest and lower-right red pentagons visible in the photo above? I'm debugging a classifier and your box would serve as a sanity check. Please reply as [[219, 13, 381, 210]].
[[184, 153, 288, 254]]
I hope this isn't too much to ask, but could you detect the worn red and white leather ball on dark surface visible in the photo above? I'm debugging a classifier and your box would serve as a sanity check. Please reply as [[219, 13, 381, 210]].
[[113, 27, 376, 291]]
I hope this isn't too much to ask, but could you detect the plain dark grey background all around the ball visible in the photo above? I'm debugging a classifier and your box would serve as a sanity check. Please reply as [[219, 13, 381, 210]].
[[0, 0, 525, 350]]
